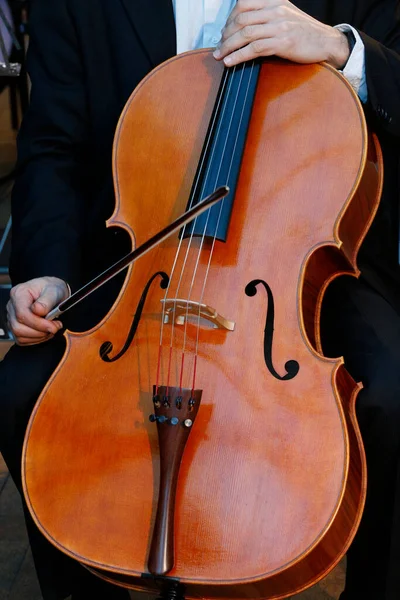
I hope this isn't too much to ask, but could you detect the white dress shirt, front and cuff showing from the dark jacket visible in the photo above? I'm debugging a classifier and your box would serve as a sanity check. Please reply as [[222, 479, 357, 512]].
[[172, 0, 368, 103]]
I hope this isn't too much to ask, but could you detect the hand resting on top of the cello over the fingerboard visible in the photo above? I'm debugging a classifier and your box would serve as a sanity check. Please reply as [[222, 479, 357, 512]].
[[214, 0, 350, 69]]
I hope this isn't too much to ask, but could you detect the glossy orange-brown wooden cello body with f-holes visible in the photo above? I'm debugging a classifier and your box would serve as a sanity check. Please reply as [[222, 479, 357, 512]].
[[23, 51, 382, 599]]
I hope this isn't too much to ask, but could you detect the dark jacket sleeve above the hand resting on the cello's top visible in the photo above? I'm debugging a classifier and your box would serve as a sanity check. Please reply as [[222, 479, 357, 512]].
[[359, 0, 400, 137]]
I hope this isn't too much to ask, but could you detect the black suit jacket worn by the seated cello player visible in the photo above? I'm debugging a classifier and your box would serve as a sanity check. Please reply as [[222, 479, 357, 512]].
[[10, 0, 400, 306]]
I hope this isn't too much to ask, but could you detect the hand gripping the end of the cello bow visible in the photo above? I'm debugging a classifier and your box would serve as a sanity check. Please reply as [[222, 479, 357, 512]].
[[7, 277, 69, 346]]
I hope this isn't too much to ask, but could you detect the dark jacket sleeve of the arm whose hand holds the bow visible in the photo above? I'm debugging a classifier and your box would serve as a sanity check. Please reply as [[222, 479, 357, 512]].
[[10, 0, 88, 287]]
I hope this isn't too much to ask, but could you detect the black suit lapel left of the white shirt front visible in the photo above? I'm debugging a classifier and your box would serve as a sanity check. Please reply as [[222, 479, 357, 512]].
[[120, 0, 176, 67]]
